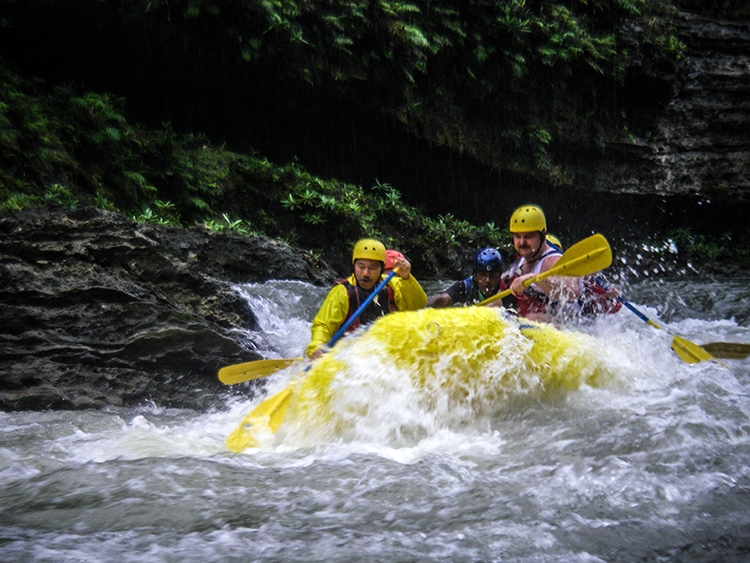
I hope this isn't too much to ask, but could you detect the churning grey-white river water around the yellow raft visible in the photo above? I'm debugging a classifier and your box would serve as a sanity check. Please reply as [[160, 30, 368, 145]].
[[0, 277, 750, 563]]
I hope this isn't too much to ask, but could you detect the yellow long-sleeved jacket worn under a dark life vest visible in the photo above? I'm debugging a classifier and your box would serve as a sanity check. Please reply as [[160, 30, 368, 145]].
[[306, 274, 427, 356]]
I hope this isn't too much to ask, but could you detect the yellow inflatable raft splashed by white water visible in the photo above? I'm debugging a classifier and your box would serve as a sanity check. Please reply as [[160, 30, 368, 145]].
[[227, 307, 612, 452]]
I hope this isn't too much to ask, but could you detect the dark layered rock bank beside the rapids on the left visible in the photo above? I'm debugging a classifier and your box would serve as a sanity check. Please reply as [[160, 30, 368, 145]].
[[0, 208, 333, 410]]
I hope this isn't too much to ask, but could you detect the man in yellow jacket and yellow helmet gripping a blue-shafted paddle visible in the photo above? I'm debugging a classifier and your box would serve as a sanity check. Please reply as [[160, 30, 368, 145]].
[[307, 239, 427, 360]]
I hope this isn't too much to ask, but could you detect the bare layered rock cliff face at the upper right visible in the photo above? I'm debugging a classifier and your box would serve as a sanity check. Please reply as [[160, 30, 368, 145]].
[[575, 12, 750, 203]]
